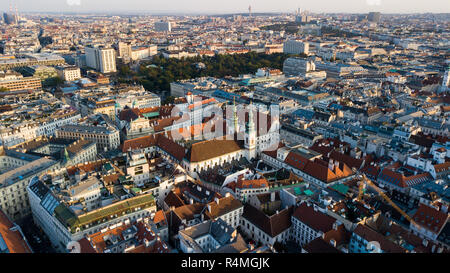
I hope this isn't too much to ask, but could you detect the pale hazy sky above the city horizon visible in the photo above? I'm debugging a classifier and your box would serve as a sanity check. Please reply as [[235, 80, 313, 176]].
[[0, 0, 450, 14]]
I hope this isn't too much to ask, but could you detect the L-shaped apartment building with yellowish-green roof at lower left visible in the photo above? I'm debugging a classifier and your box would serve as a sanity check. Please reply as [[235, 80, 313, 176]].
[[27, 177, 156, 252]]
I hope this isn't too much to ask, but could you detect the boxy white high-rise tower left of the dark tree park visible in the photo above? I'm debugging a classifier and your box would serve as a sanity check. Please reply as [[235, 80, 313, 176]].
[[85, 46, 117, 73]]
